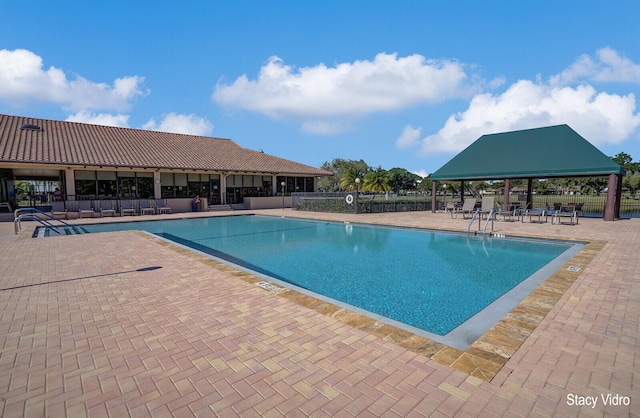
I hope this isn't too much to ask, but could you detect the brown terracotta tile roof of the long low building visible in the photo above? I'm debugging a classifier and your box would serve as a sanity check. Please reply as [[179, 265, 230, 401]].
[[0, 114, 333, 176]]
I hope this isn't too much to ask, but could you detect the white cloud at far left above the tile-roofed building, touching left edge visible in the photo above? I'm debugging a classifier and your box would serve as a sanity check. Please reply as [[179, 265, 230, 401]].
[[0, 49, 148, 111]]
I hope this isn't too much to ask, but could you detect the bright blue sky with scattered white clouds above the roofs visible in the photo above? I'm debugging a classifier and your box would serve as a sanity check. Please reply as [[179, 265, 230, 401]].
[[0, 0, 640, 175]]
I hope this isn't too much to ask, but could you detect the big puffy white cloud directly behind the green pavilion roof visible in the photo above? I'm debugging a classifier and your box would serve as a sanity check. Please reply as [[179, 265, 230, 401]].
[[421, 80, 640, 155]]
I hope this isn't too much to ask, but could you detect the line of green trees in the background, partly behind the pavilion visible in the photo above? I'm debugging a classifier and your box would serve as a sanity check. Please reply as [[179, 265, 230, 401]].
[[318, 152, 640, 196]]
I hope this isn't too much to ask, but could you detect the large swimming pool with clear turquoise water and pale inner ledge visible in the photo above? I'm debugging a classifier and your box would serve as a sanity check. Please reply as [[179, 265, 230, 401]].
[[42, 215, 581, 349]]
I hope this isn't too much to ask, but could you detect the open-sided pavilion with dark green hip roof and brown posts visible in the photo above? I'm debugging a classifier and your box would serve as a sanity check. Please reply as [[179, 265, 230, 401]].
[[430, 125, 626, 221]]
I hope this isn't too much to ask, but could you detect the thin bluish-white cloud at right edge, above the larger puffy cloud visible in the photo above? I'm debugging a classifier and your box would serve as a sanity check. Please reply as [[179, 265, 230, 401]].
[[550, 48, 640, 86]]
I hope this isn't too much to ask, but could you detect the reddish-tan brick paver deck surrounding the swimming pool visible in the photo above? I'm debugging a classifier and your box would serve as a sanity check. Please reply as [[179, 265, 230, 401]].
[[0, 210, 640, 417]]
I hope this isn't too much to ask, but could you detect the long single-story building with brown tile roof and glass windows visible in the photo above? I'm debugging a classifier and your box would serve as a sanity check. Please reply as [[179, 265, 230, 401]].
[[0, 115, 333, 212]]
